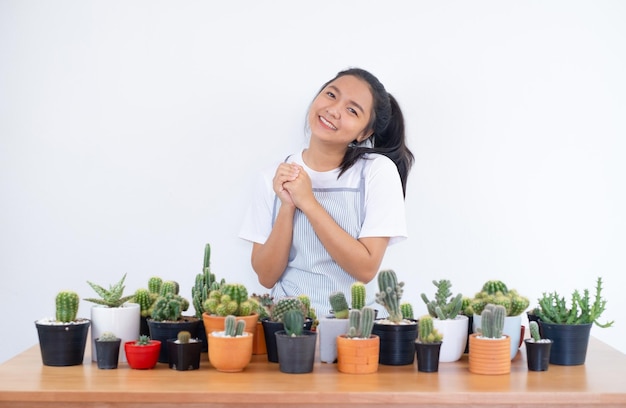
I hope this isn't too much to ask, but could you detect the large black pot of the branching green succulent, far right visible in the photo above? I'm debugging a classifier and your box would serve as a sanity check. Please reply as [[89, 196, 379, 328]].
[[539, 321, 593, 366]]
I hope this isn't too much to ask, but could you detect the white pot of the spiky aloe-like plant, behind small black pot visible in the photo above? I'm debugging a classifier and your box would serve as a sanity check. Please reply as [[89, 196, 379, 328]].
[[91, 303, 140, 363]]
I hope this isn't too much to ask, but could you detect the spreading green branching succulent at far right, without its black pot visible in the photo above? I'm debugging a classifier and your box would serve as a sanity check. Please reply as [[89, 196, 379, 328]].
[[536, 277, 614, 328]]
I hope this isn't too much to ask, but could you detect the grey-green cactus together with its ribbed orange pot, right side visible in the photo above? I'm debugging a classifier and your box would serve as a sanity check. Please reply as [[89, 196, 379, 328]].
[[469, 304, 511, 375]]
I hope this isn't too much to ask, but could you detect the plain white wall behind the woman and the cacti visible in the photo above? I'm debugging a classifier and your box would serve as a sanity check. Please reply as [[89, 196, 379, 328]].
[[0, 0, 626, 361]]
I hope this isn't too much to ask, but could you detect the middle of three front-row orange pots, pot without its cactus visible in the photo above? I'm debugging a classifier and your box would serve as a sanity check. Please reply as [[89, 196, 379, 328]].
[[337, 334, 380, 374]]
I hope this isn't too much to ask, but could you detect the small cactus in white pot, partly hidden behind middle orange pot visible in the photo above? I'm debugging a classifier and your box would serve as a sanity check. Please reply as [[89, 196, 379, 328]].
[[319, 291, 358, 363]]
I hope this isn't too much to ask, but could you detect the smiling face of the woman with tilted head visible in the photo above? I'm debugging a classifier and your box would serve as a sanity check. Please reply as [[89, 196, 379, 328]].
[[309, 75, 374, 147]]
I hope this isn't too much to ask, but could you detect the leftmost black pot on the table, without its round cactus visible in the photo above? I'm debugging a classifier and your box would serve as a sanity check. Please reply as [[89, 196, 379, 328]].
[[35, 319, 91, 366]]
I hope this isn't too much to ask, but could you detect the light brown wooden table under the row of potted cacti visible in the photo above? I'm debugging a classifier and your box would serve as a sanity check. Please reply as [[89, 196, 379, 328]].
[[0, 338, 626, 408]]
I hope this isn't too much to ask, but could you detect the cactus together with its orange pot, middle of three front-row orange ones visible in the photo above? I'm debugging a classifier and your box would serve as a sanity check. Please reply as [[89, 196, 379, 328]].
[[336, 307, 380, 374]]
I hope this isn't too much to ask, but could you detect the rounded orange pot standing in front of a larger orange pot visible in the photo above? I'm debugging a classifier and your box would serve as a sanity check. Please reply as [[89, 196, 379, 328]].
[[207, 332, 254, 373]]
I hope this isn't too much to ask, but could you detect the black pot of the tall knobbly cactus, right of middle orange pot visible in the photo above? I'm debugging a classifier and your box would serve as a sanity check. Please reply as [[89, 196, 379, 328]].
[[372, 320, 417, 365]]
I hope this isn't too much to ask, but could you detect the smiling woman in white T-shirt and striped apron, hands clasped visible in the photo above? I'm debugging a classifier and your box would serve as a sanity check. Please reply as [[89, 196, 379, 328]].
[[240, 68, 413, 316]]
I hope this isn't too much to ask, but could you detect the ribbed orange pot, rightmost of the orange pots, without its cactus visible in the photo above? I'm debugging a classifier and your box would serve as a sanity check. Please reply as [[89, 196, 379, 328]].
[[469, 333, 511, 375]]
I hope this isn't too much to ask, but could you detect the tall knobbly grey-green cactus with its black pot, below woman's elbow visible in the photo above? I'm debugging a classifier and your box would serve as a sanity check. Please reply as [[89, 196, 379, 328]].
[[372, 269, 417, 365]]
